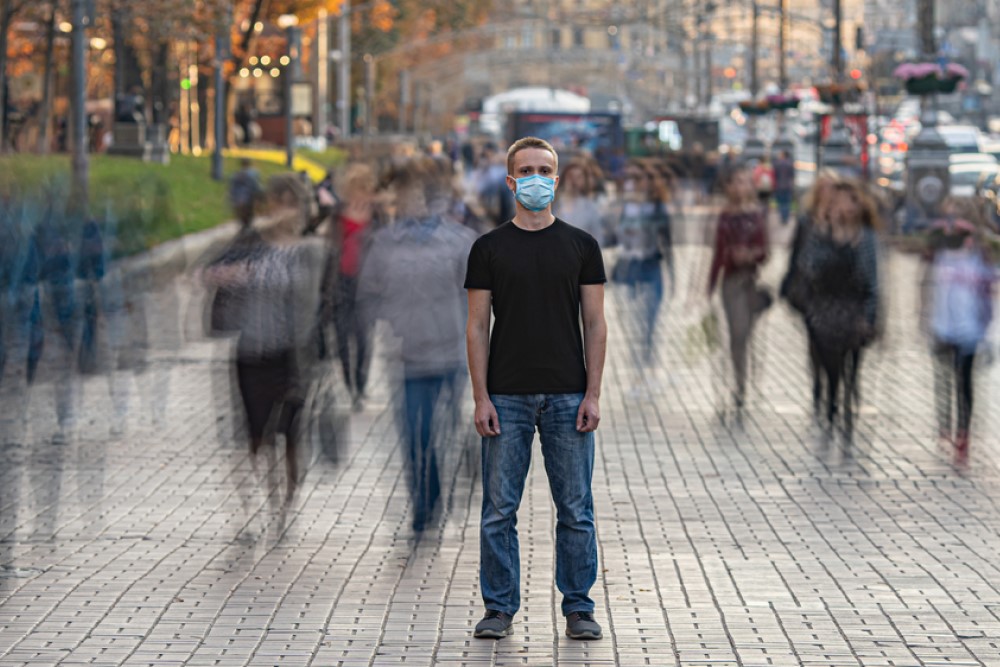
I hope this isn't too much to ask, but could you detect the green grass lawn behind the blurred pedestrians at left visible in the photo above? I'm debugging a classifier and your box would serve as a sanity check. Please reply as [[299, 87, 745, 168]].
[[0, 154, 308, 253]]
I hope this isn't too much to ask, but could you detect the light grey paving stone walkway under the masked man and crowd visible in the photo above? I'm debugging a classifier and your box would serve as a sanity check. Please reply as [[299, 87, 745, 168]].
[[0, 213, 1000, 667]]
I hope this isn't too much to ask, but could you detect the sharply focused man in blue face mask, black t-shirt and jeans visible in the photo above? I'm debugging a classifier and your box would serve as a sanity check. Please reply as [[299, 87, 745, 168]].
[[465, 137, 607, 639]]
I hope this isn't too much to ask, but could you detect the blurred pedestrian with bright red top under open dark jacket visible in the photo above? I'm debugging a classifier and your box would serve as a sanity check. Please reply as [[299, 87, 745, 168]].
[[321, 162, 383, 408]]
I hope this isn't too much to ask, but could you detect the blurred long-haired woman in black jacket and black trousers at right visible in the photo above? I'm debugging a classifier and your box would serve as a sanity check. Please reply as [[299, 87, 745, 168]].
[[797, 181, 879, 439]]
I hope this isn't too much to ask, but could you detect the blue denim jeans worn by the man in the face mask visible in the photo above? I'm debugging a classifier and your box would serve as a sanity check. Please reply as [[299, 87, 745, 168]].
[[479, 394, 597, 616]]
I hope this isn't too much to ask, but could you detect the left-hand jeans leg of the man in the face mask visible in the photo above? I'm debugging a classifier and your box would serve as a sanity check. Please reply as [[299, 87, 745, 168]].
[[479, 394, 541, 616]]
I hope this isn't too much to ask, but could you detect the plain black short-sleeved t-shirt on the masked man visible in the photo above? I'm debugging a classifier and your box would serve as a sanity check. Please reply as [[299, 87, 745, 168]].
[[465, 218, 606, 394]]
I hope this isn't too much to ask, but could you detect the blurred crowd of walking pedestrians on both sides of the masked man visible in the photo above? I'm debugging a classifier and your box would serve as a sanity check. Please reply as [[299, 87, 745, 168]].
[[0, 143, 996, 548]]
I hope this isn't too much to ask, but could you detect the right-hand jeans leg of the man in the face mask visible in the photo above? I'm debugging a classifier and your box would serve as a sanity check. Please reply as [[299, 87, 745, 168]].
[[540, 394, 597, 616]]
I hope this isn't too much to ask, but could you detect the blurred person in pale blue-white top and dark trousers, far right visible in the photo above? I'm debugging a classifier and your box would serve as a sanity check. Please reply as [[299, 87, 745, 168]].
[[922, 197, 996, 458]]
